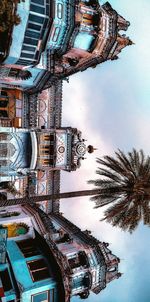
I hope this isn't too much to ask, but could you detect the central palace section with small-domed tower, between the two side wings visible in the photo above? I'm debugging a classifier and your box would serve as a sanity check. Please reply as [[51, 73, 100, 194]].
[[0, 80, 94, 212]]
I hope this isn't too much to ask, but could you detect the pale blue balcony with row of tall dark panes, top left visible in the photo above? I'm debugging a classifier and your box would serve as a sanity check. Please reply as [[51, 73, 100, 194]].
[[4, 0, 50, 66]]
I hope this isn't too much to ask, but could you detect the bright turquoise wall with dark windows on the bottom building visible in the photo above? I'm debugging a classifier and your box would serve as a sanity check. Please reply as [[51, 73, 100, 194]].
[[0, 238, 63, 302]]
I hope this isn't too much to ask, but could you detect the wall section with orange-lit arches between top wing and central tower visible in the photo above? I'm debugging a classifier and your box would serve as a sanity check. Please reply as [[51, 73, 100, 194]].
[[0, 81, 63, 129]]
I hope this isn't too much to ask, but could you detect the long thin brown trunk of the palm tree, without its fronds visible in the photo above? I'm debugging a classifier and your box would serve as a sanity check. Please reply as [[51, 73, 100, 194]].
[[0, 189, 100, 207]]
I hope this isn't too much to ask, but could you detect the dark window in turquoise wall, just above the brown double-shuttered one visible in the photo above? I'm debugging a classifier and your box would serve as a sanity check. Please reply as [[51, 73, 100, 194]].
[[16, 239, 39, 258]]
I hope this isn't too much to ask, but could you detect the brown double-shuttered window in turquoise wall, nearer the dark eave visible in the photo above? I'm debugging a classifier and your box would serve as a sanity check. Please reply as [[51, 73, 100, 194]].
[[27, 258, 50, 282]]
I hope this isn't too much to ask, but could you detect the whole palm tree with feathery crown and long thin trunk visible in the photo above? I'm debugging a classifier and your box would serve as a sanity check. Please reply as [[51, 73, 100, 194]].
[[0, 149, 150, 232]]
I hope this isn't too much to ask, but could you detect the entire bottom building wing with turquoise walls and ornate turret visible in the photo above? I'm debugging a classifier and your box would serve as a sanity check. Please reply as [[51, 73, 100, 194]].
[[0, 204, 121, 302]]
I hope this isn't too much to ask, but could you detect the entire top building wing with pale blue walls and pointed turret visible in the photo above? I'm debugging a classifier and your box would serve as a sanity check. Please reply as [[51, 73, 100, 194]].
[[0, 0, 132, 94]]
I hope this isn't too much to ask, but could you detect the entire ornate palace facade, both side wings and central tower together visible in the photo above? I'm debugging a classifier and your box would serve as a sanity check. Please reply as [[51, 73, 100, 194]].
[[0, 0, 132, 302]]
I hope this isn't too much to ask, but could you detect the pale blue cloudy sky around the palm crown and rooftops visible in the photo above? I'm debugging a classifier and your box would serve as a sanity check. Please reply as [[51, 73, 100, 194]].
[[61, 0, 150, 302]]
